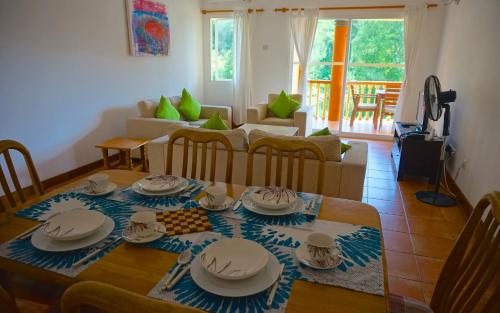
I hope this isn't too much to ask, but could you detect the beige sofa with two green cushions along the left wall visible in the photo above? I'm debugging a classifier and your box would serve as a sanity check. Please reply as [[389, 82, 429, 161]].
[[131, 97, 233, 130]]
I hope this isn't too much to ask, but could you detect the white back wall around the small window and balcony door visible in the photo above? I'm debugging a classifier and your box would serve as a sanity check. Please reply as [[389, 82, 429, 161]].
[[202, 0, 444, 121]]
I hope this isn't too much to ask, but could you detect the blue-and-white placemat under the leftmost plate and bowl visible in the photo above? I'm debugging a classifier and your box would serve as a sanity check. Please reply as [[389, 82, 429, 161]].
[[0, 192, 134, 277]]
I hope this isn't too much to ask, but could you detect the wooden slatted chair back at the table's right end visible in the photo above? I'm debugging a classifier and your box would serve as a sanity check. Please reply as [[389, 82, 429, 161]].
[[430, 192, 500, 313]]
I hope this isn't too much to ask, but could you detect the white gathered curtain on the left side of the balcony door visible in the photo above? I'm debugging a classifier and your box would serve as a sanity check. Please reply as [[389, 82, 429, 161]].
[[290, 9, 319, 99]]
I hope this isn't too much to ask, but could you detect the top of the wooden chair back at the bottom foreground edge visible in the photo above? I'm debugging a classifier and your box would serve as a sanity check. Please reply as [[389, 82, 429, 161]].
[[61, 281, 202, 313]]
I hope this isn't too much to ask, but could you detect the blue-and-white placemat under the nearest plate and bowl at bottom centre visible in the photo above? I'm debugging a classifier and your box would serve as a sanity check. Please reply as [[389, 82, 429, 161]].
[[148, 233, 298, 313]]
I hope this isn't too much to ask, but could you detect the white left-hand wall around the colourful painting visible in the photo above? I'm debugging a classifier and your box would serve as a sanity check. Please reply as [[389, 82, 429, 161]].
[[0, 0, 203, 185]]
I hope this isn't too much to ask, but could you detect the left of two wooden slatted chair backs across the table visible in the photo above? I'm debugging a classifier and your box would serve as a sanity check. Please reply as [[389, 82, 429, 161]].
[[166, 129, 233, 184]]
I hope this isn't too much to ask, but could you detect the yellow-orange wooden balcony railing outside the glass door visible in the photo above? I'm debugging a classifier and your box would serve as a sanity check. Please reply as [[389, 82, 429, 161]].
[[308, 80, 401, 120]]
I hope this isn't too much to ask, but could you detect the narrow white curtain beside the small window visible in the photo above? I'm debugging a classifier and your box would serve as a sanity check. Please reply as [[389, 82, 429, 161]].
[[233, 10, 255, 125]]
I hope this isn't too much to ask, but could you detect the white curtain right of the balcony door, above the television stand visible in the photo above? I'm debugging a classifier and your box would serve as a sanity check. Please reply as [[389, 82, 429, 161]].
[[394, 3, 427, 121]]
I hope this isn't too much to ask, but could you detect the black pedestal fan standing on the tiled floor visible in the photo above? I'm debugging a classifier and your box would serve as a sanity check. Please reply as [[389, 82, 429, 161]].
[[415, 75, 457, 206]]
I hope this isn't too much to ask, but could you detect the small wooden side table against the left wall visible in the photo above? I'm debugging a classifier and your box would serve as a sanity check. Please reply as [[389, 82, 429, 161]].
[[96, 137, 150, 172]]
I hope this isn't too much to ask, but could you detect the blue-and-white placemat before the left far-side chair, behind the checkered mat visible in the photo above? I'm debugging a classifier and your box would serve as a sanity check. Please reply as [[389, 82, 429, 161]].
[[111, 179, 210, 211]]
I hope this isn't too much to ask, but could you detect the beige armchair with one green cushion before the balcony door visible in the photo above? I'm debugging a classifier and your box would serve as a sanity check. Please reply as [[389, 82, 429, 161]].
[[247, 94, 313, 136]]
